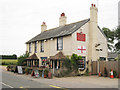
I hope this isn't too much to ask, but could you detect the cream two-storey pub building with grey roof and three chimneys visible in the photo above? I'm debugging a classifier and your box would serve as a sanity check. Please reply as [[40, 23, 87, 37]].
[[26, 4, 107, 74]]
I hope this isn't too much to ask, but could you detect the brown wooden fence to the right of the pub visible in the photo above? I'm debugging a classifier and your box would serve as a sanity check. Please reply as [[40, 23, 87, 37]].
[[92, 61, 120, 75]]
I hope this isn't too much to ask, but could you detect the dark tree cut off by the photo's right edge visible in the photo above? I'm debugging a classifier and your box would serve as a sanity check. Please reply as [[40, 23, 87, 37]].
[[115, 26, 120, 53]]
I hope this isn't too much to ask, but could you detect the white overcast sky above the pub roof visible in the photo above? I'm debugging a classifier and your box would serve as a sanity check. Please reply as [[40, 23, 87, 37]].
[[0, 0, 120, 56]]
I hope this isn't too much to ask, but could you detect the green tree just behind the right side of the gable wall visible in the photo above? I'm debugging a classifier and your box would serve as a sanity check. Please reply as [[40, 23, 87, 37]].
[[102, 27, 115, 51]]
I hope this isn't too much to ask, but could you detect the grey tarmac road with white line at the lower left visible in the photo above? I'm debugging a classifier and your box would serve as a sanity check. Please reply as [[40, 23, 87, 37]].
[[0, 66, 55, 88]]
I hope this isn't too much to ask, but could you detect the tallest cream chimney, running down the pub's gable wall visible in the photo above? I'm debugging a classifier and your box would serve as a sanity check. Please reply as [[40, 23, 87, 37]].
[[88, 4, 99, 72]]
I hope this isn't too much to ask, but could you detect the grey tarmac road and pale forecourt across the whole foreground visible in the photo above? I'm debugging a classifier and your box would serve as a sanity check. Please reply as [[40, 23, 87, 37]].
[[0, 67, 118, 90]]
